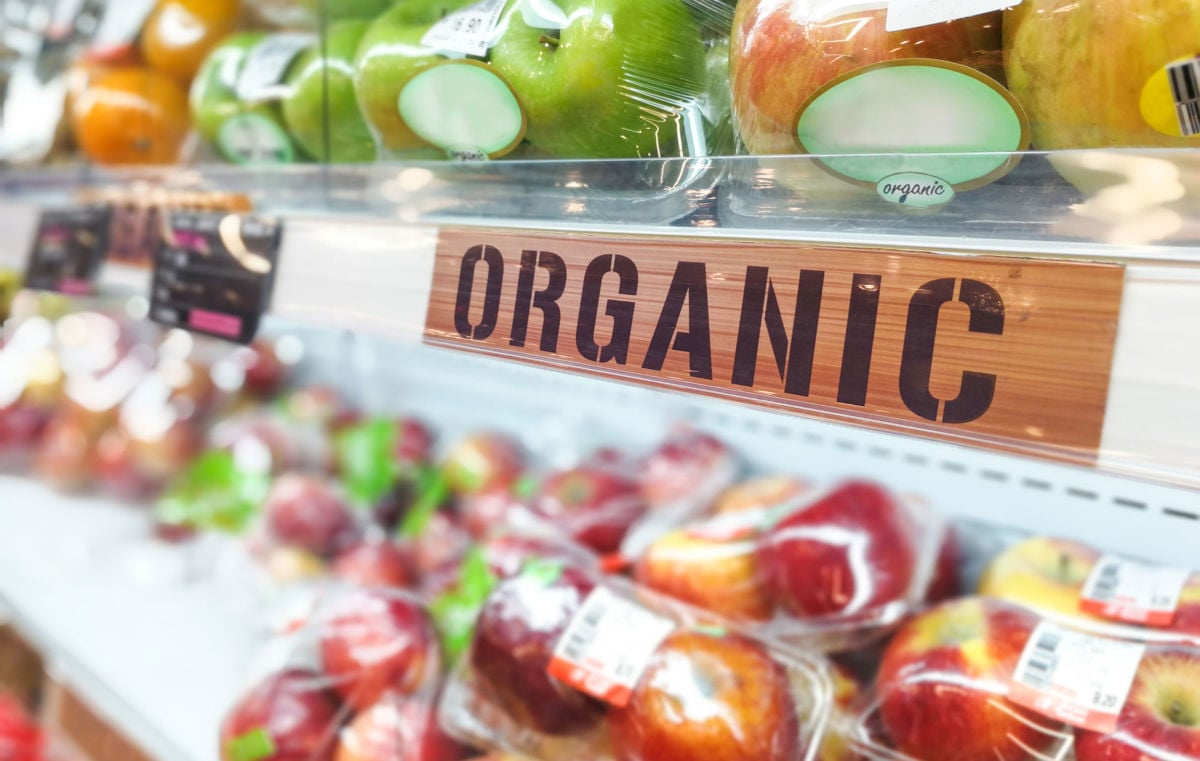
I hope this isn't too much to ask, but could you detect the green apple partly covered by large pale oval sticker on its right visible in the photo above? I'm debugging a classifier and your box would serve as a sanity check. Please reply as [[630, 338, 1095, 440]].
[[354, 0, 475, 157]]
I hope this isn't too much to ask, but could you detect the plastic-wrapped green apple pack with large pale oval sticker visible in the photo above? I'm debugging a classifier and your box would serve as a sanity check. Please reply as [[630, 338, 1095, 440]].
[[354, 0, 732, 160]]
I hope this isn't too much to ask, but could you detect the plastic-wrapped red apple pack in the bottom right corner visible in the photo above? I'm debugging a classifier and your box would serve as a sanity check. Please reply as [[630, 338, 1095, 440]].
[[851, 597, 1200, 761]]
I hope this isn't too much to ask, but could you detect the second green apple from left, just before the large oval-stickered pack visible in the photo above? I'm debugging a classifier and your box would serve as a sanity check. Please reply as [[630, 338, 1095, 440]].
[[283, 20, 376, 163]]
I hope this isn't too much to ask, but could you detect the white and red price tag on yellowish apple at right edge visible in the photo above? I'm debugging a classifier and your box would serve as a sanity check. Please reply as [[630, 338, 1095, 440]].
[[1079, 555, 1190, 627]]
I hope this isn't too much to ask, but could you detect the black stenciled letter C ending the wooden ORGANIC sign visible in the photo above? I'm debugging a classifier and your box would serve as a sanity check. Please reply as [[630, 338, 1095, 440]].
[[900, 277, 1004, 424]]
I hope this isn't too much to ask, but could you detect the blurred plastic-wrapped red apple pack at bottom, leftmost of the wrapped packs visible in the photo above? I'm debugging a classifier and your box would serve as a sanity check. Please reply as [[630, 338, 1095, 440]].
[[220, 588, 466, 761]]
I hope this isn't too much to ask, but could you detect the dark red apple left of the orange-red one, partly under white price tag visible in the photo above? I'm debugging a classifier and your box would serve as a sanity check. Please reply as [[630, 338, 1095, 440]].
[[470, 567, 604, 735]]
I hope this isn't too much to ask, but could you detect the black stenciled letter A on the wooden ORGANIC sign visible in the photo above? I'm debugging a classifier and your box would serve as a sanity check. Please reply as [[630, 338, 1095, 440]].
[[642, 262, 713, 381]]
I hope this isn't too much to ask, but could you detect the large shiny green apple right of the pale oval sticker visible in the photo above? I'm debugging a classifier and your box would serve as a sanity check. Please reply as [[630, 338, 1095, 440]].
[[491, 0, 706, 158]]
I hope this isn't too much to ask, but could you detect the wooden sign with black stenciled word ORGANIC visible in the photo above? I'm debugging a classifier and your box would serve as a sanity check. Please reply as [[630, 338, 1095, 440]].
[[425, 229, 1124, 459]]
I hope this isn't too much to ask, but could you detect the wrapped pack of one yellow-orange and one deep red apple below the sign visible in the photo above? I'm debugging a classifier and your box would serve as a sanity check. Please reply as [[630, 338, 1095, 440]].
[[634, 477, 956, 651]]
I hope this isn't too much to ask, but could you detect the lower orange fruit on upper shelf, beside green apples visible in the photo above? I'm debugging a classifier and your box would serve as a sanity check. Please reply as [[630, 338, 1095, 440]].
[[71, 68, 190, 164]]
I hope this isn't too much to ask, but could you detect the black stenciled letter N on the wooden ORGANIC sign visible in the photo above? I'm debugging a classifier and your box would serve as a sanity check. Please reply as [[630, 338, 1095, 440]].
[[731, 266, 824, 396]]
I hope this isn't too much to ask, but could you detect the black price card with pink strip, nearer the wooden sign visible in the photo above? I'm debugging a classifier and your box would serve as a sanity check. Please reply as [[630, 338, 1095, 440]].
[[150, 211, 283, 343]]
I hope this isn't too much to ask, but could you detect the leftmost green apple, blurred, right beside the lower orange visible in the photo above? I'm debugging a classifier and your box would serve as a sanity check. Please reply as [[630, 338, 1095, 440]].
[[191, 32, 298, 163]]
